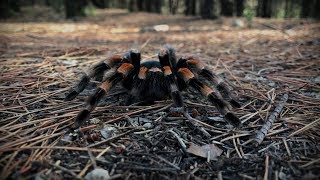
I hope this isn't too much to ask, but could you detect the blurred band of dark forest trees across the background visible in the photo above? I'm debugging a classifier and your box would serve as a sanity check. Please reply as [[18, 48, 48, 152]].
[[0, 0, 320, 19]]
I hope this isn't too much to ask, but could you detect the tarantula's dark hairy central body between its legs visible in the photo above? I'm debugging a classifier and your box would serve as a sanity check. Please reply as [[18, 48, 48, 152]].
[[130, 60, 170, 102]]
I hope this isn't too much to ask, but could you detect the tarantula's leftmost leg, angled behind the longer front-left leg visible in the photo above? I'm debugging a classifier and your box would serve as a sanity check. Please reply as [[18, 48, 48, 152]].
[[64, 55, 122, 101]]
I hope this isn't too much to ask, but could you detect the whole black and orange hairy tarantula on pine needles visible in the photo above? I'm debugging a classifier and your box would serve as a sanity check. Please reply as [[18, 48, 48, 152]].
[[65, 46, 241, 127]]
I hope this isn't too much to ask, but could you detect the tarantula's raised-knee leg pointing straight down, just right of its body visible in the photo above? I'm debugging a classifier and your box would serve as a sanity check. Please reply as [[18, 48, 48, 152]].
[[158, 46, 183, 108]]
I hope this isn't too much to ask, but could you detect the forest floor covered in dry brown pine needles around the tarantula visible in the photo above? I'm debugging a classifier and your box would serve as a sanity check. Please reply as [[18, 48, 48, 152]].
[[0, 6, 320, 179]]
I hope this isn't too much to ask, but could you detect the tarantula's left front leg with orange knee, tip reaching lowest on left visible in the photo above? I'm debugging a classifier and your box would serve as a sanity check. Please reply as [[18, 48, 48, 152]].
[[75, 63, 134, 127]]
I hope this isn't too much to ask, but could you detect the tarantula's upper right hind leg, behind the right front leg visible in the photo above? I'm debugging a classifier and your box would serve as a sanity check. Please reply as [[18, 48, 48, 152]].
[[177, 57, 241, 108]]
